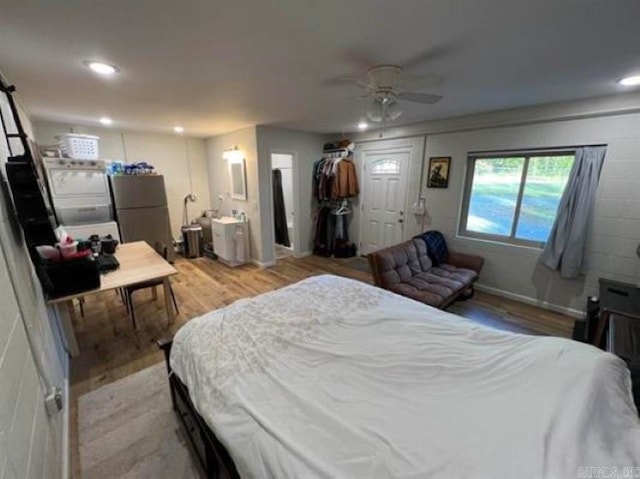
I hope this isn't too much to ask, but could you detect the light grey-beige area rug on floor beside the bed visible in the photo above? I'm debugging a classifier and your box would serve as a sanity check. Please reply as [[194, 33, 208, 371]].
[[78, 363, 201, 479]]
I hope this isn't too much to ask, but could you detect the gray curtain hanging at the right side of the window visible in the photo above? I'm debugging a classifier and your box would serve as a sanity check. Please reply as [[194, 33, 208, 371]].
[[540, 146, 607, 278]]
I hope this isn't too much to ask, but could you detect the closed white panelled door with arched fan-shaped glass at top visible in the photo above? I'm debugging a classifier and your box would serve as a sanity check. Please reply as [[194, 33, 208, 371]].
[[360, 149, 411, 255]]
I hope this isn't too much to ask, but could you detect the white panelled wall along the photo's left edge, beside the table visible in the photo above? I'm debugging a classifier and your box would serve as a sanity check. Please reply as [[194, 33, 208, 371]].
[[0, 89, 69, 479]]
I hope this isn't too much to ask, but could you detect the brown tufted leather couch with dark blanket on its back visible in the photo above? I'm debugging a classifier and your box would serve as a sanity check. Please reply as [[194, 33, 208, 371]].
[[367, 238, 484, 309]]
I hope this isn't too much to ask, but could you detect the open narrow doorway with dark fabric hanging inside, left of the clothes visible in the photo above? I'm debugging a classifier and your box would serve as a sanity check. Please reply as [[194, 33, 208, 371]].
[[271, 153, 295, 259]]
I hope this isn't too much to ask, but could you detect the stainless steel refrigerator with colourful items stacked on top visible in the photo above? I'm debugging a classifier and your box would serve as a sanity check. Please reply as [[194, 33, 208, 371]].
[[110, 175, 175, 261]]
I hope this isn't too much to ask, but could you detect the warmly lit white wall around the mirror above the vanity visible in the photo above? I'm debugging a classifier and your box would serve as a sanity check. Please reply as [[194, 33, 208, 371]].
[[206, 127, 264, 262]]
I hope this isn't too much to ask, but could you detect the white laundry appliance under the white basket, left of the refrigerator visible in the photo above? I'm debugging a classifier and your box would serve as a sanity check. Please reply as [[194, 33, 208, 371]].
[[43, 158, 113, 226]]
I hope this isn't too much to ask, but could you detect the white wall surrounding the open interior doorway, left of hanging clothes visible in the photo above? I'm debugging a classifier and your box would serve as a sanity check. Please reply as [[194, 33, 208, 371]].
[[257, 125, 327, 263]]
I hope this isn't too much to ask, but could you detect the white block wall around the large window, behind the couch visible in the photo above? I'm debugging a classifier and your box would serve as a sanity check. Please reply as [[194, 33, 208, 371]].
[[352, 95, 640, 314]]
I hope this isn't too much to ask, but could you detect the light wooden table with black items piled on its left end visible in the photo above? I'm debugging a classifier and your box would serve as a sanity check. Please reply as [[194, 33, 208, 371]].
[[48, 241, 178, 357]]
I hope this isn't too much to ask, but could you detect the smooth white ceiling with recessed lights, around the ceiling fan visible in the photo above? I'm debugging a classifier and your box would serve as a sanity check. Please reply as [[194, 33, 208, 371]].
[[0, 0, 640, 136]]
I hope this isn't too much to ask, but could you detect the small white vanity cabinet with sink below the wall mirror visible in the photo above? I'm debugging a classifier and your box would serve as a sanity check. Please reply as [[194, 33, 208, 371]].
[[211, 216, 250, 266]]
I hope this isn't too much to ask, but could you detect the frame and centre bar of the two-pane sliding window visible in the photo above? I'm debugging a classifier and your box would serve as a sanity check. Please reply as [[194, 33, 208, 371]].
[[458, 148, 576, 249]]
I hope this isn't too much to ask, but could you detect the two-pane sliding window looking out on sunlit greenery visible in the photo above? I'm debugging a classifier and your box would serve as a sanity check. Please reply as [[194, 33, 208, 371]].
[[460, 151, 575, 246]]
